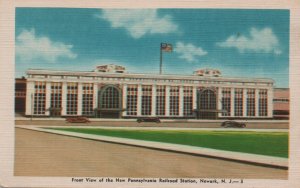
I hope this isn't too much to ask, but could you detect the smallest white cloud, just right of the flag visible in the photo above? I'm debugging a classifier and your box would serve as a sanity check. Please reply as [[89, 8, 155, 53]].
[[174, 42, 207, 62]]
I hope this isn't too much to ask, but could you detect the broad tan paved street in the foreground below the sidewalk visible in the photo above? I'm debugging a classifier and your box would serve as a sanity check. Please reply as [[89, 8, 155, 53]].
[[15, 128, 288, 179]]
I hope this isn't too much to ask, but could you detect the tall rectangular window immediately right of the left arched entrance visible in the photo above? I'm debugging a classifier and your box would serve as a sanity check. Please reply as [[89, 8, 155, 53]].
[[127, 85, 138, 116]]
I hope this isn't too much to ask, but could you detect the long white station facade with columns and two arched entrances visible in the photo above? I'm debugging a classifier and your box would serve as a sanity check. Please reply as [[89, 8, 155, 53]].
[[25, 64, 274, 119]]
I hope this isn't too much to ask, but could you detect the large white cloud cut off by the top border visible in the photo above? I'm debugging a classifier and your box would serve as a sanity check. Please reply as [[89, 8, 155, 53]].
[[97, 9, 178, 39]]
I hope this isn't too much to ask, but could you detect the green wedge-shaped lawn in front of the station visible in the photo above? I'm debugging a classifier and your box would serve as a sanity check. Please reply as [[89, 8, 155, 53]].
[[51, 128, 288, 158]]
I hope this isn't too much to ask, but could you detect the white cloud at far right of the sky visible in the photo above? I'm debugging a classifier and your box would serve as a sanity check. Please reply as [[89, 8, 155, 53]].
[[217, 27, 282, 55]]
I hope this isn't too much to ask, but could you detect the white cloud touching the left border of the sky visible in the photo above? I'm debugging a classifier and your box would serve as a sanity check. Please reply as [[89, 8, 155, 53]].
[[16, 29, 77, 62]]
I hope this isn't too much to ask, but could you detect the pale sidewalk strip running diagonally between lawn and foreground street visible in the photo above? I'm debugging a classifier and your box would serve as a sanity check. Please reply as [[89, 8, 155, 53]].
[[16, 125, 288, 169]]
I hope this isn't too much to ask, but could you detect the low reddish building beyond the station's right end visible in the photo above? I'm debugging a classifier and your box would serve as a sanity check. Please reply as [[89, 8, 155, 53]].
[[273, 88, 290, 119]]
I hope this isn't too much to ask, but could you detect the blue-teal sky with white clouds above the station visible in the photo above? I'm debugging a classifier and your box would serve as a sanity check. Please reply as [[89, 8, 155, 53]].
[[15, 8, 289, 87]]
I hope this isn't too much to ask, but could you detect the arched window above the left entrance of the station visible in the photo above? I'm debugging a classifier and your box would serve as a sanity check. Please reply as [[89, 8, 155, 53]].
[[101, 86, 120, 109]]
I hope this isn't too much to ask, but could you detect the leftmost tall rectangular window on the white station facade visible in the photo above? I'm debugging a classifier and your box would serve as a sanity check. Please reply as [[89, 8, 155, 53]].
[[33, 82, 46, 115]]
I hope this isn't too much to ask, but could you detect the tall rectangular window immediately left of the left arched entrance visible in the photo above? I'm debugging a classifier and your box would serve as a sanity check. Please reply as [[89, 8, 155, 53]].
[[82, 83, 94, 116]]
